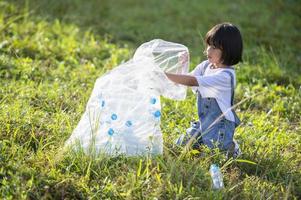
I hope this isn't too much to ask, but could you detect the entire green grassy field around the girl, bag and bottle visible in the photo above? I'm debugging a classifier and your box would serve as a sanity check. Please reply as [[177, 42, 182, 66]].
[[0, 0, 301, 199]]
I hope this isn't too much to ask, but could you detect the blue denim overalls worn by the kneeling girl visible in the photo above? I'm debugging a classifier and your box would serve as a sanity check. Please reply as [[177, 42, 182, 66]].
[[176, 63, 240, 154]]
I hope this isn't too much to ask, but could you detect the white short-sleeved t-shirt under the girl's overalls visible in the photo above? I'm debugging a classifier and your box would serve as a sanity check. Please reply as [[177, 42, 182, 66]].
[[190, 60, 236, 122]]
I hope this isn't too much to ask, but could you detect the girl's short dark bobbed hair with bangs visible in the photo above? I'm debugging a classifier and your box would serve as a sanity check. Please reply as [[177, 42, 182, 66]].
[[205, 23, 243, 65]]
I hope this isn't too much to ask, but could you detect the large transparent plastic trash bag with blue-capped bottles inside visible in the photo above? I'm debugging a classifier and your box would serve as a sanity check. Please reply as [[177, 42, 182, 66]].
[[65, 39, 189, 155]]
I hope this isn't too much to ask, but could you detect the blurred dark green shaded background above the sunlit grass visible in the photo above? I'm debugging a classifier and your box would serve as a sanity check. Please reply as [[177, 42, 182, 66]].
[[11, 0, 301, 72]]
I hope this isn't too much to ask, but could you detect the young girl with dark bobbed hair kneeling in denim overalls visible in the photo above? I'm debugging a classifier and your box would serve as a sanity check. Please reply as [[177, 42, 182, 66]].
[[166, 23, 243, 156]]
